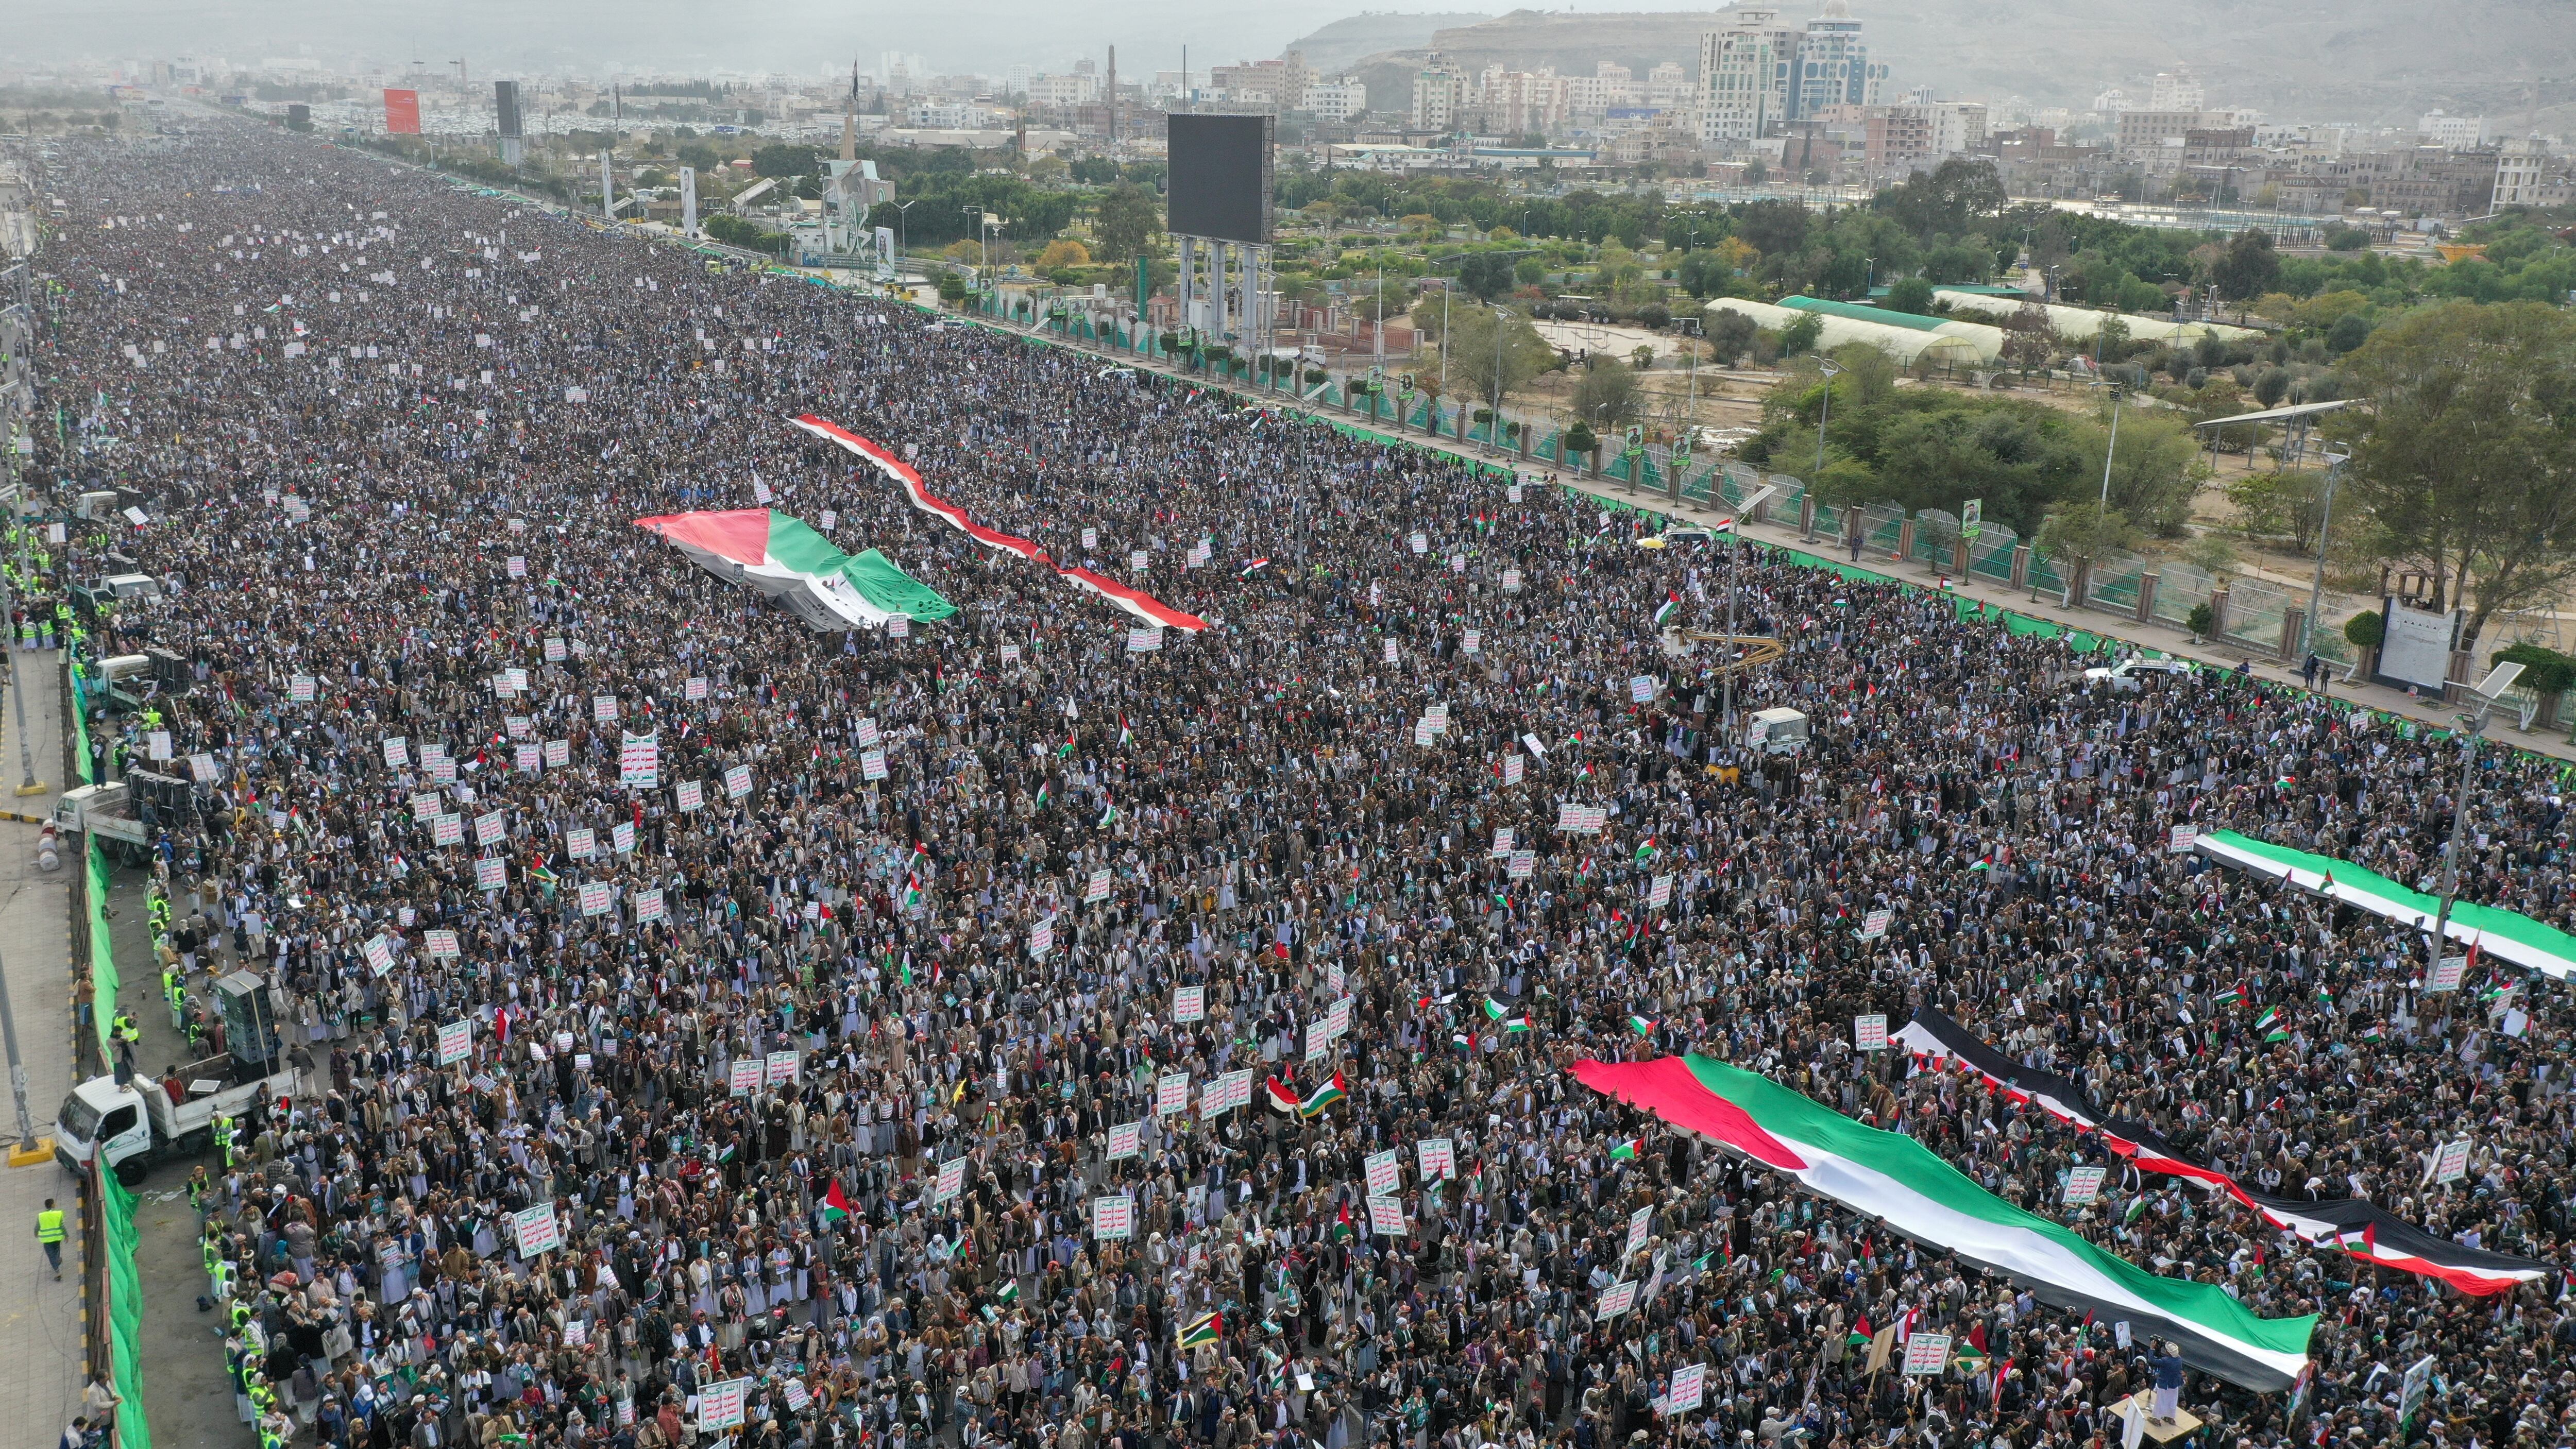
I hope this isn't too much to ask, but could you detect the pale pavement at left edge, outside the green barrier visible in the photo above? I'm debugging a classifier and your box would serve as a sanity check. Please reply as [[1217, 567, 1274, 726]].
[[0, 654, 85, 1449]]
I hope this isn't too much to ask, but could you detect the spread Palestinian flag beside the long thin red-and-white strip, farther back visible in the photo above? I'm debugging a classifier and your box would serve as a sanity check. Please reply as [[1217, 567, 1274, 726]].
[[636, 507, 958, 633]]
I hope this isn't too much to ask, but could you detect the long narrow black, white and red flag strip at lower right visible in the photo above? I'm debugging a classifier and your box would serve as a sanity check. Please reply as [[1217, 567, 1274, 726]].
[[1891, 1012, 2555, 1294]]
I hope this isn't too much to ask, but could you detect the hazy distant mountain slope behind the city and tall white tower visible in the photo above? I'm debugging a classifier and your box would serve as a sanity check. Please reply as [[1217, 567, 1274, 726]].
[[1340, 0, 2576, 134]]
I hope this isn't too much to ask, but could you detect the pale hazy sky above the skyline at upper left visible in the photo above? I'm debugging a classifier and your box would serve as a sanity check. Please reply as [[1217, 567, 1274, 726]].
[[0, 0, 1718, 75]]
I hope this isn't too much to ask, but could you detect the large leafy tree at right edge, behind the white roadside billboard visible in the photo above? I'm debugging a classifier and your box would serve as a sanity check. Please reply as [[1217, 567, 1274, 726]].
[[2336, 301, 2576, 649]]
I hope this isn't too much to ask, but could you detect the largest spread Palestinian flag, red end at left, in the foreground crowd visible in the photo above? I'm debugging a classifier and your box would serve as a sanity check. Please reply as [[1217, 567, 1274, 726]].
[[1574, 1055, 2316, 1392]]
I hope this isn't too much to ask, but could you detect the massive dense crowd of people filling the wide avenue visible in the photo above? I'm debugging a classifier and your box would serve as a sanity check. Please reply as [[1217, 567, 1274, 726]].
[[33, 126, 2576, 1449]]
